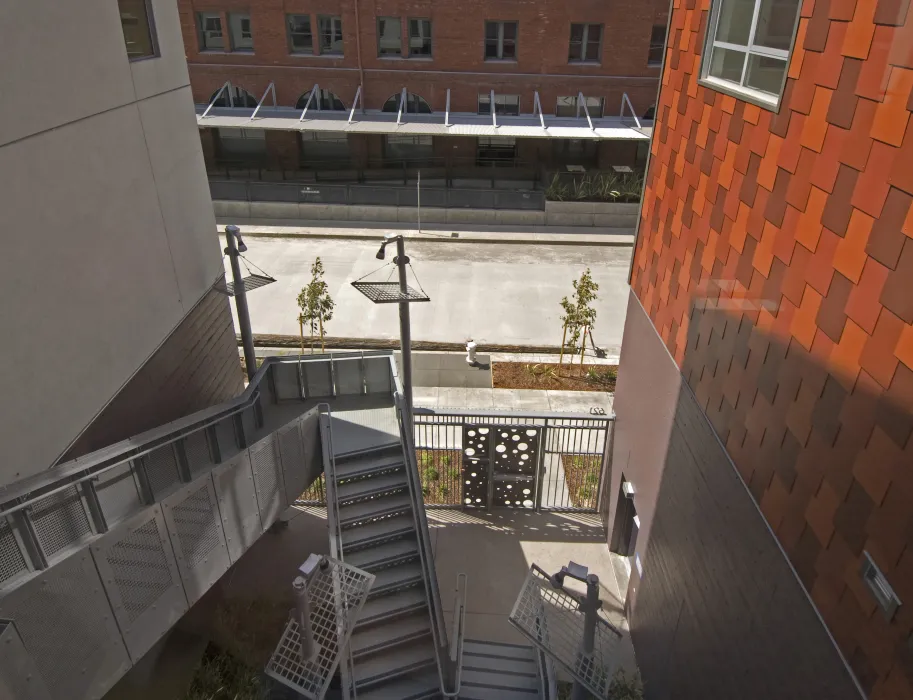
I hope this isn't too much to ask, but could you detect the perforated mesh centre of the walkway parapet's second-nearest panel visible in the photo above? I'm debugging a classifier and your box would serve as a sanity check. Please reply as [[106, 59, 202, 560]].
[[105, 520, 172, 622]]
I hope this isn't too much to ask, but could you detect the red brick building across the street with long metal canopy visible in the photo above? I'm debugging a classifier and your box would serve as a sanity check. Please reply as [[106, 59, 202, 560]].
[[178, 0, 668, 183]]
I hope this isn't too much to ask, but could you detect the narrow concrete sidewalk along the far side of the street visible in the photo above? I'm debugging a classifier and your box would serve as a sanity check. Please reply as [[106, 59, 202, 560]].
[[217, 224, 634, 246]]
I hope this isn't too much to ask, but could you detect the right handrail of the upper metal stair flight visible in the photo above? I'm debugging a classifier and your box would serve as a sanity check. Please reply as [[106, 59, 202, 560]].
[[393, 391, 453, 697]]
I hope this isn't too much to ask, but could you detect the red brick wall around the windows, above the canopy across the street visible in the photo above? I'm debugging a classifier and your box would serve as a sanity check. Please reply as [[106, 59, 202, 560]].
[[178, 0, 668, 115]]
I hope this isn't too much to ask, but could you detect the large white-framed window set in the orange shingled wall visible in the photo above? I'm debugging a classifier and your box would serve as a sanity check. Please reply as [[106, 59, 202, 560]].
[[701, 0, 800, 108]]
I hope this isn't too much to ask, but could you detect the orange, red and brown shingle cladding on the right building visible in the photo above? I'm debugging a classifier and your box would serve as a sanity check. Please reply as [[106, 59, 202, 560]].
[[632, 0, 913, 698]]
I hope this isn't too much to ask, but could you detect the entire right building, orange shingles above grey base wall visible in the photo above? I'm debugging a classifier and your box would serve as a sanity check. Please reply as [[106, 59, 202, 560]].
[[613, 0, 913, 698]]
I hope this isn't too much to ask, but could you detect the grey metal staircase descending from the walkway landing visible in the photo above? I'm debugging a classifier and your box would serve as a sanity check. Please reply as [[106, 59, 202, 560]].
[[321, 404, 455, 700]]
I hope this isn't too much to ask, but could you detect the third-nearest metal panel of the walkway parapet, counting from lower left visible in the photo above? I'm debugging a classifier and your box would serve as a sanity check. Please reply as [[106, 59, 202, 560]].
[[162, 474, 230, 605]]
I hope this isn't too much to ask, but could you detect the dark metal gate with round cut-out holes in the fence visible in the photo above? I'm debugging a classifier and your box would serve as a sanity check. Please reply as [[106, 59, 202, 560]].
[[462, 423, 542, 509]]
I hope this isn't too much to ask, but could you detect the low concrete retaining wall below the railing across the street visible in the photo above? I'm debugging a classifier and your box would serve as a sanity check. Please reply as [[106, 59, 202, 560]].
[[213, 200, 640, 229]]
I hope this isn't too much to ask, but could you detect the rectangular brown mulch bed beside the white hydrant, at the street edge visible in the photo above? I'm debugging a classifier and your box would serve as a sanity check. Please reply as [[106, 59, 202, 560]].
[[491, 362, 618, 391]]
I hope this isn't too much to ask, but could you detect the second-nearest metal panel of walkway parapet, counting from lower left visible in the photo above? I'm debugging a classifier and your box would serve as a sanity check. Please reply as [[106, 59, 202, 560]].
[[92, 506, 187, 663]]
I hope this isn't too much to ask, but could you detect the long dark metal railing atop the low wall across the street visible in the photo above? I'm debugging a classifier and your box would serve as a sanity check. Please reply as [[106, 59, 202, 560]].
[[209, 179, 545, 211]]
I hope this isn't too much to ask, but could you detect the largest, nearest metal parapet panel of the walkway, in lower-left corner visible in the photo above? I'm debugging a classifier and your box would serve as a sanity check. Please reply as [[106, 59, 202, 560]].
[[0, 550, 130, 698]]
